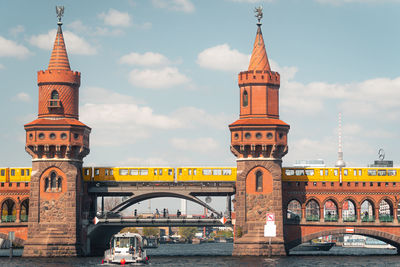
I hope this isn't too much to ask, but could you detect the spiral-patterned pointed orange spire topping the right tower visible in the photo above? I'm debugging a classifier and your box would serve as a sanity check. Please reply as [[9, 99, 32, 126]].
[[248, 7, 271, 71]]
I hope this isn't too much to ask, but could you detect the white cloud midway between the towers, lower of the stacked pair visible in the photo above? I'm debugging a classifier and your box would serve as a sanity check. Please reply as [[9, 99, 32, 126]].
[[129, 67, 190, 89]]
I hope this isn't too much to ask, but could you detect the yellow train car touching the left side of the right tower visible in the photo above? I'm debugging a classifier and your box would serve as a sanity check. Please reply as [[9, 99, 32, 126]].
[[176, 167, 237, 182]]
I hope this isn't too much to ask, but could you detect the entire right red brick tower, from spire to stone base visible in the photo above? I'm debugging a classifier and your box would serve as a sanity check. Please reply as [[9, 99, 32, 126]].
[[229, 9, 289, 256]]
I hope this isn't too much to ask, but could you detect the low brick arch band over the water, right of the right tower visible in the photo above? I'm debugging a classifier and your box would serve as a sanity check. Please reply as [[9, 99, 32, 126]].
[[286, 227, 400, 251]]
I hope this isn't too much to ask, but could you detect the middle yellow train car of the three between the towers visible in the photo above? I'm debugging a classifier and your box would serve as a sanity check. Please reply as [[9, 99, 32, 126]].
[[111, 167, 175, 182]]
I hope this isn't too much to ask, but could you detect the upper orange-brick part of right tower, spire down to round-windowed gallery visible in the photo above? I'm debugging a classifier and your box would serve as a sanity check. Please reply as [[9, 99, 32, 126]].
[[229, 6, 289, 159]]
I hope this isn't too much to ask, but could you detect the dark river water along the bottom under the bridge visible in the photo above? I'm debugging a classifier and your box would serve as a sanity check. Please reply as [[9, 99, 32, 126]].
[[0, 243, 400, 267]]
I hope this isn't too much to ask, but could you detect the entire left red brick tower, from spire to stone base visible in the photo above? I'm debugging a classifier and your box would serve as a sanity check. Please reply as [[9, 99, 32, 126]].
[[24, 7, 90, 257]]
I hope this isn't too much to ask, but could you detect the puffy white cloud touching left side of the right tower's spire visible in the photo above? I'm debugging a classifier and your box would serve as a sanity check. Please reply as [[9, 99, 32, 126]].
[[197, 44, 250, 72]]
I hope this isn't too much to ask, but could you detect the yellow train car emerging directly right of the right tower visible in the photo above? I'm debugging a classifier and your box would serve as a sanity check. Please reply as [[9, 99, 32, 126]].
[[282, 167, 340, 182]]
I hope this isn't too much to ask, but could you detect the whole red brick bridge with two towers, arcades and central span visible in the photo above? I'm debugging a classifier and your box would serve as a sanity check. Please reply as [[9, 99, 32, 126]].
[[0, 6, 400, 257]]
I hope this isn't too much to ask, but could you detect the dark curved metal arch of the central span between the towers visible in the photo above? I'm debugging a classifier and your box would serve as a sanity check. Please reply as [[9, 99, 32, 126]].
[[110, 192, 219, 217]]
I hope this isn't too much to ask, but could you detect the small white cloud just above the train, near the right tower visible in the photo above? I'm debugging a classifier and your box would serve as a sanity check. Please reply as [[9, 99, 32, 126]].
[[170, 137, 218, 153]]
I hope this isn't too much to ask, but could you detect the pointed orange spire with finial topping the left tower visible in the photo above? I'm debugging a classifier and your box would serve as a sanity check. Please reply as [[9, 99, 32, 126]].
[[48, 7, 71, 70]]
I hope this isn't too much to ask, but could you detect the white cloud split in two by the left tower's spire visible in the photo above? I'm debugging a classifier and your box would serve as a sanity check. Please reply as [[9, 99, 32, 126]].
[[29, 30, 97, 55]]
